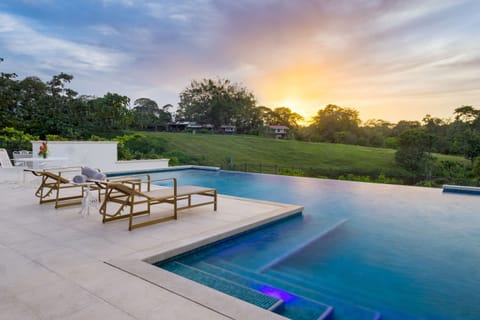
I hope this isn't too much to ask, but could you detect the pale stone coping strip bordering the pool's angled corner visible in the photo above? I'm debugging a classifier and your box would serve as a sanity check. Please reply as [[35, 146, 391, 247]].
[[105, 195, 304, 320]]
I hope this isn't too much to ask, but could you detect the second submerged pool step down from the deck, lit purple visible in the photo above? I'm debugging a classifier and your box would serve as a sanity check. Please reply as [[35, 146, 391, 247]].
[[195, 262, 333, 320]]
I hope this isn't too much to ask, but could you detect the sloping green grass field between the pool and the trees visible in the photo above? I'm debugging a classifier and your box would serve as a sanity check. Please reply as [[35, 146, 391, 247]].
[[147, 132, 464, 177]]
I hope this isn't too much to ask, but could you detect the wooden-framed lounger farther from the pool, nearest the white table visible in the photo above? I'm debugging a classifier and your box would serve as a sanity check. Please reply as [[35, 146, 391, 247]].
[[26, 169, 85, 209]]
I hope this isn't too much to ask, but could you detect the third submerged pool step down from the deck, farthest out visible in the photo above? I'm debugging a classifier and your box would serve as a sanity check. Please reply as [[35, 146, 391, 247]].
[[211, 259, 382, 320]]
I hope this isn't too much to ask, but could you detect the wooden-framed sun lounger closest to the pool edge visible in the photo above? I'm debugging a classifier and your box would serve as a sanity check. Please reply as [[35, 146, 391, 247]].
[[98, 178, 217, 230]]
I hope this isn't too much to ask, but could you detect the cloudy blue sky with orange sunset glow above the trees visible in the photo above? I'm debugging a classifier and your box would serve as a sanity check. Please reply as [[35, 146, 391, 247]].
[[0, 0, 480, 123]]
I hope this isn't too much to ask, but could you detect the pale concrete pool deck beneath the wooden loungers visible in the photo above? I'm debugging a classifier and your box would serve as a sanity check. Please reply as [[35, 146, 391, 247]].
[[0, 182, 303, 320]]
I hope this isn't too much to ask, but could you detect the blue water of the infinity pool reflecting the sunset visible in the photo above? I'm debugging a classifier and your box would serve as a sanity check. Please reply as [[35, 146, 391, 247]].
[[153, 170, 480, 320]]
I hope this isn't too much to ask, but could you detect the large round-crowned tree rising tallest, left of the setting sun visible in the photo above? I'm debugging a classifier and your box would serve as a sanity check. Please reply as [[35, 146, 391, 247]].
[[178, 79, 255, 129]]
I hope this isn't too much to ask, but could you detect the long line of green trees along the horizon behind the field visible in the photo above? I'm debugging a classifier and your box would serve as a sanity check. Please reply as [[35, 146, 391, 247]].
[[0, 58, 480, 180]]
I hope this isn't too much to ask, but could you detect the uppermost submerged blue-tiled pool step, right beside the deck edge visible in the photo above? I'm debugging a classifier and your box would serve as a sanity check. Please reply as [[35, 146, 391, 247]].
[[162, 261, 283, 311]]
